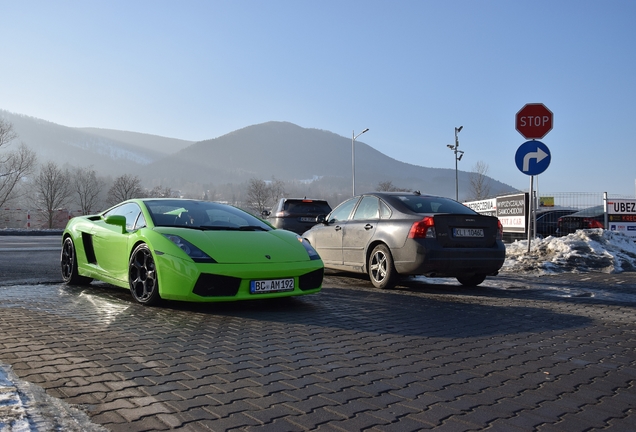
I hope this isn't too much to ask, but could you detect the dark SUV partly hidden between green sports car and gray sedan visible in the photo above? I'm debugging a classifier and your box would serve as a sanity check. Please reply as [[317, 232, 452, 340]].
[[263, 198, 331, 234]]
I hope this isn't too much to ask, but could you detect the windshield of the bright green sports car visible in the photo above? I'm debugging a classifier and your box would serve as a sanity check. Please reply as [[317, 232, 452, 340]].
[[144, 199, 272, 231]]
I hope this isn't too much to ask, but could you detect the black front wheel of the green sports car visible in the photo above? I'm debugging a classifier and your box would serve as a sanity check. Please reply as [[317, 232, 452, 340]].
[[128, 243, 161, 305]]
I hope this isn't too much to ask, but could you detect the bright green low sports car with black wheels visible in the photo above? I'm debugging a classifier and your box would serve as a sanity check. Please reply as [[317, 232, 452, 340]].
[[60, 198, 324, 305]]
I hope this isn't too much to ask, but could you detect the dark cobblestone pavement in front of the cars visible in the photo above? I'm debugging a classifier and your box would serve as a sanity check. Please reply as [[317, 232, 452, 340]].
[[0, 273, 636, 432]]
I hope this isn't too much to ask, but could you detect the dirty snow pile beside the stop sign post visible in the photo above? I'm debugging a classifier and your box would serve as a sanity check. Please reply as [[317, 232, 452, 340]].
[[501, 229, 636, 274]]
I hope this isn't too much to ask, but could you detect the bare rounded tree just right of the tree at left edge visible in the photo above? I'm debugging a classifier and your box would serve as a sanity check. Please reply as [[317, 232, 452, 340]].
[[32, 162, 73, 228]]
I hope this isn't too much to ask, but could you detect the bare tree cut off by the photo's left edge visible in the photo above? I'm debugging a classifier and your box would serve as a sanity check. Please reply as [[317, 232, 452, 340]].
[[0, 118, 36, 208]]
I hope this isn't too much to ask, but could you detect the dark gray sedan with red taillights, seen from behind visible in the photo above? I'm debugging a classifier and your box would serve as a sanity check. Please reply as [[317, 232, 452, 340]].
[[303, 192, 506, 288]]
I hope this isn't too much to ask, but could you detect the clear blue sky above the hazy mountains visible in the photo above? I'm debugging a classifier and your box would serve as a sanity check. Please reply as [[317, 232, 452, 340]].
[[0, 0, 636, 196]]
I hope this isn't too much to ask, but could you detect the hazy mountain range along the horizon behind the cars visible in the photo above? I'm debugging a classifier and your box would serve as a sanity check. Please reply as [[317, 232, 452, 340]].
[[0, 110, 515, 204]]
